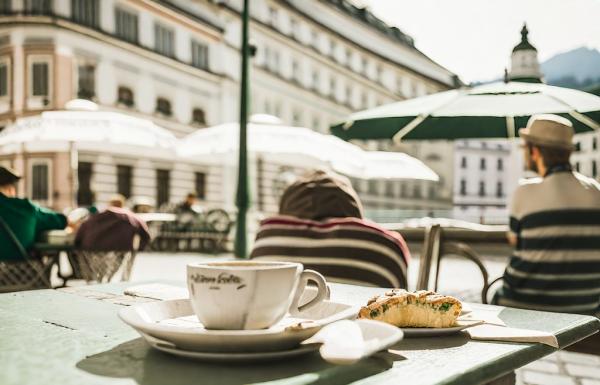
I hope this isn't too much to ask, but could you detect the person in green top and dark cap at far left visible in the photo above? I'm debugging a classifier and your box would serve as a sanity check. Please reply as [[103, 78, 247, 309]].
[[0, 167, 67, 260]]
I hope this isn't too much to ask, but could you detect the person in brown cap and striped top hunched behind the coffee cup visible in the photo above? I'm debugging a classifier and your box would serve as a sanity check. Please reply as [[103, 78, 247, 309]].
[[251, 171, 410, 288]]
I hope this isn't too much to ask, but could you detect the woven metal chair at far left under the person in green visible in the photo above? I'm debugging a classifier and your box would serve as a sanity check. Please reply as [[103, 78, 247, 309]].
[[0, 217, 55, 293]]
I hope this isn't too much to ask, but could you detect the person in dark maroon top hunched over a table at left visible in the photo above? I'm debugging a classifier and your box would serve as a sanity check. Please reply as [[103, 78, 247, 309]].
[[75, 195, 150, 251]]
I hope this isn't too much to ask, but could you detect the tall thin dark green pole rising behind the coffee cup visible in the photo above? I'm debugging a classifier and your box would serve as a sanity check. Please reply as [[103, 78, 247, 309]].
[[234, 0, 250, 258]]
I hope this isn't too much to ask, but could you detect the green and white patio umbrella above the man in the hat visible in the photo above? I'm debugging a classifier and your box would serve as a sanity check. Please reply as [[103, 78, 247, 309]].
[[331, 82, 600, 141]]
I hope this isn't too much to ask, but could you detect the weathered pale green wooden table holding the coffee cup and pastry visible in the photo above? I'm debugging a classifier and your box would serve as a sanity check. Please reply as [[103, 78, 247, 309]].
[[0, 283, 600, 385]]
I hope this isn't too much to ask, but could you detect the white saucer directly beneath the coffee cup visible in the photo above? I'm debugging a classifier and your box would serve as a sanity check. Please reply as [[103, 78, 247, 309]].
[[119, 292, 359, 354]]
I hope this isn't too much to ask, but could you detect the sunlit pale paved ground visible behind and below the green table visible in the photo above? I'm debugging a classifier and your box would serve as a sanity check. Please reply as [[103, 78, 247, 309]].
[[124, 253, 600, 385]]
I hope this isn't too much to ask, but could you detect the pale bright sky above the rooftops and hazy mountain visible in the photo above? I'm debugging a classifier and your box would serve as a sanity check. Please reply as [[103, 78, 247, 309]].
[[357, 0, 600, 83]]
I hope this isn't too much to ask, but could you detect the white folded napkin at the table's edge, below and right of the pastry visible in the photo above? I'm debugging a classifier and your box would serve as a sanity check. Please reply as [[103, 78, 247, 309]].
[[466, 324, 558, 349]]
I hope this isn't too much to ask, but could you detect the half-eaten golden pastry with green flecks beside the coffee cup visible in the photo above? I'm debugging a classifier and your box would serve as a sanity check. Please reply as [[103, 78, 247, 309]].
[[358, 289, 462, 328]]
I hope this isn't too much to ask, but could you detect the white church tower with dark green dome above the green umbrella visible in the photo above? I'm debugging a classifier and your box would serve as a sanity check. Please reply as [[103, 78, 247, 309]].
[[508, 24, 543, 83]]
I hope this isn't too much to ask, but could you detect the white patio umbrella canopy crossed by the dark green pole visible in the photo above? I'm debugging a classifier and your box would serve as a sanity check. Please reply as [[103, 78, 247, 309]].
[[177, 115, 439, 181]]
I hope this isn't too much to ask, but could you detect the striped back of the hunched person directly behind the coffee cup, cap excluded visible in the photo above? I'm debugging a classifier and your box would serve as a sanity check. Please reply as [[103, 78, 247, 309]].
[[251, 216, 410, 288]]
